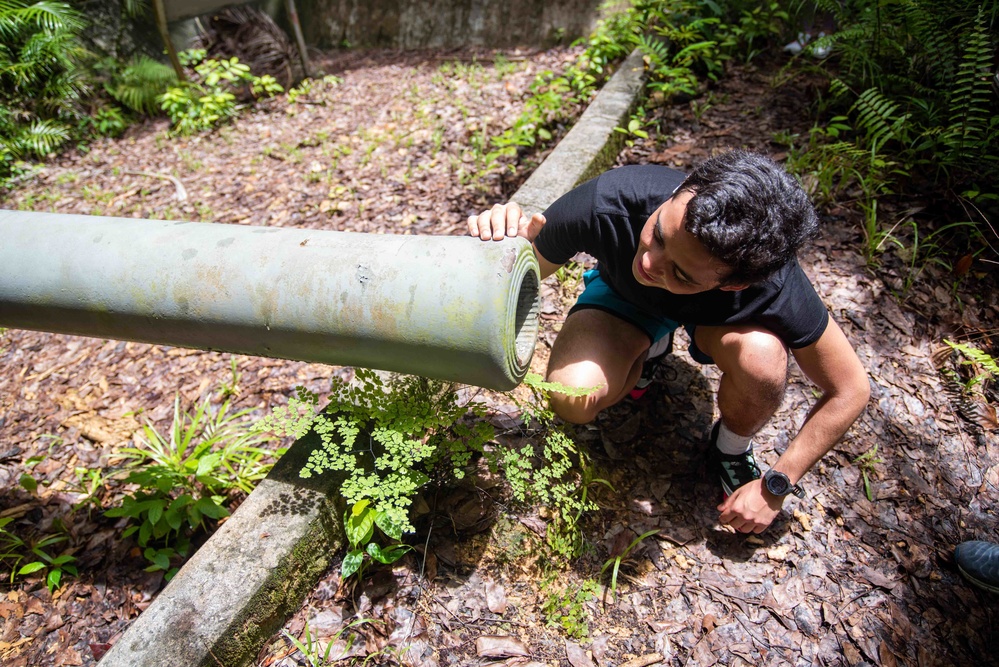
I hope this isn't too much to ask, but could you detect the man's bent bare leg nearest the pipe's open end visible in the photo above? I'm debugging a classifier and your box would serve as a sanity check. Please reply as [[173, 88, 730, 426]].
[[548, 308, 649, 424]]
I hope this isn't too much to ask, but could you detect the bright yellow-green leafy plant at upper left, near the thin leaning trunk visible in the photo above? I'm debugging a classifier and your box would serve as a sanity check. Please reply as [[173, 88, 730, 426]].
[[159, 49, 283, 135]]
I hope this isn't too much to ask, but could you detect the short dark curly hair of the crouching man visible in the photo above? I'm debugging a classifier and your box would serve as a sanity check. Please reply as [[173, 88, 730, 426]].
[[677, 150, 818, 285]]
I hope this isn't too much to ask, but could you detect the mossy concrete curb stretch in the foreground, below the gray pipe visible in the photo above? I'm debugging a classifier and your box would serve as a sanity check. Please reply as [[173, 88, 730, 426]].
[[100, 433, 346, 667]]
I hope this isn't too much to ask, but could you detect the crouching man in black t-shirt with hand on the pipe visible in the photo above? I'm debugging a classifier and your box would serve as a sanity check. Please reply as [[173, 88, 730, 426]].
[[468, 151, 870, 533]]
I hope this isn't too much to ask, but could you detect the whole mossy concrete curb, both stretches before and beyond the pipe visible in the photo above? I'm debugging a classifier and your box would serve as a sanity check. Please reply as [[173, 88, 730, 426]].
[[100, 52, 645, 667]]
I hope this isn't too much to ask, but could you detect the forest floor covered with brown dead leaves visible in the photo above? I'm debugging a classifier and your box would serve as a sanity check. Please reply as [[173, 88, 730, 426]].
[[0, 44, 999, 667]]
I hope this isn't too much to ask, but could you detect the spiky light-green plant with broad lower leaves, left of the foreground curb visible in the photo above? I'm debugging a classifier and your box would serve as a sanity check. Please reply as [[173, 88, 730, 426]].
[[106, 396, 281, 578]]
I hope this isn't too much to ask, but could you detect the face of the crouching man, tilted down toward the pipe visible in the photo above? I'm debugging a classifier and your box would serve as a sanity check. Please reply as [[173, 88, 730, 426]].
[[631, 191, 744, 294]]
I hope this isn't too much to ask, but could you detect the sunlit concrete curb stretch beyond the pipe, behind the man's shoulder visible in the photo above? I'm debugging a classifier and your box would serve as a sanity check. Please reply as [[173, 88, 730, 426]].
[[511, 49, 646, 215]]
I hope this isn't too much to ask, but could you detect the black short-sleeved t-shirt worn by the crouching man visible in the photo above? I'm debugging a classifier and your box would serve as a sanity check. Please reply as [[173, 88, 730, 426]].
[[535, 165, 829, 348]]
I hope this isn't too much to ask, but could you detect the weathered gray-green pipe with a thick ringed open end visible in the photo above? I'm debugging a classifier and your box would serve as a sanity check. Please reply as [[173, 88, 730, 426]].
[[0, 211, 538, 390]]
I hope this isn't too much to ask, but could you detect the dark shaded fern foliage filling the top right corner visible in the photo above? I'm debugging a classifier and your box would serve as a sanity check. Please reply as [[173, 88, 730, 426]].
[[798, 0, 999, 274]]
